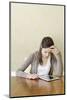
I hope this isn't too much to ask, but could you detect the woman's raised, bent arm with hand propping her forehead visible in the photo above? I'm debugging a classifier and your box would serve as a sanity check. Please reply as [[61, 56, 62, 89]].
[[50, 46, 63, 76]]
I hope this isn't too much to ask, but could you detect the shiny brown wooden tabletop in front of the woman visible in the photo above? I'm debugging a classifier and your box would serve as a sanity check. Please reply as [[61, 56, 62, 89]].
[[10, 77, 64, 97]]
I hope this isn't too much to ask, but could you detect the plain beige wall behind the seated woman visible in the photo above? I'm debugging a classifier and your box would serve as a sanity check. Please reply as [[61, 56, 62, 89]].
[[11, 3, 64, 70]]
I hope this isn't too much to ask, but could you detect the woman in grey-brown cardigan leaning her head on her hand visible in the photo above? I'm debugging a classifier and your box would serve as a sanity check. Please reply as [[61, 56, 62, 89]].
[[16, 37, 63, 79]]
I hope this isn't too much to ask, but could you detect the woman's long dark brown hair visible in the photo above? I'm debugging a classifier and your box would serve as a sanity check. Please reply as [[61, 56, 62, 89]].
[[39, 37, 54, 64]]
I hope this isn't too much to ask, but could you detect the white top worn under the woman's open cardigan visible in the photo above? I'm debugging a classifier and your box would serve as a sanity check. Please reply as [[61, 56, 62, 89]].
[[37, 56, 51, 75]]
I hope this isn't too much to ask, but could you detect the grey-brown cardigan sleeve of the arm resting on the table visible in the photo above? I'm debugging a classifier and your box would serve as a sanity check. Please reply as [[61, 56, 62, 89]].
[[16, 53, 34, 78]]
